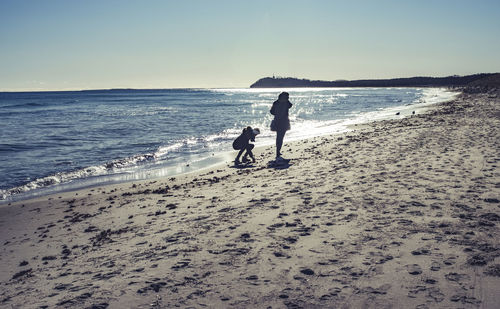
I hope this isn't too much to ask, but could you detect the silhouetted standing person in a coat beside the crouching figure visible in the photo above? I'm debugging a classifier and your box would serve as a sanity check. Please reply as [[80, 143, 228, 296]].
[[271, 92, 292, 160]]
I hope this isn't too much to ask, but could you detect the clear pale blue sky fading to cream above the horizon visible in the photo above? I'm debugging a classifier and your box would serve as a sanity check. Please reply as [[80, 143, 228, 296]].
[[0, 0, 500, 91]]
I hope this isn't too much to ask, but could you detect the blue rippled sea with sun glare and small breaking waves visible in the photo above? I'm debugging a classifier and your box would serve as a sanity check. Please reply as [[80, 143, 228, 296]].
[[0, 88, 457, 203]]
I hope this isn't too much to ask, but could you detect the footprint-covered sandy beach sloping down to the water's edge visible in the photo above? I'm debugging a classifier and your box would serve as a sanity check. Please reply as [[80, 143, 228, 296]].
[[0, 90, 500, 308]]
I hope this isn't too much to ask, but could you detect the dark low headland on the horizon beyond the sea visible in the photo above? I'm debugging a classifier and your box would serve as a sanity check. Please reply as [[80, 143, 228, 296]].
[[250, 73, 500, 88]]
